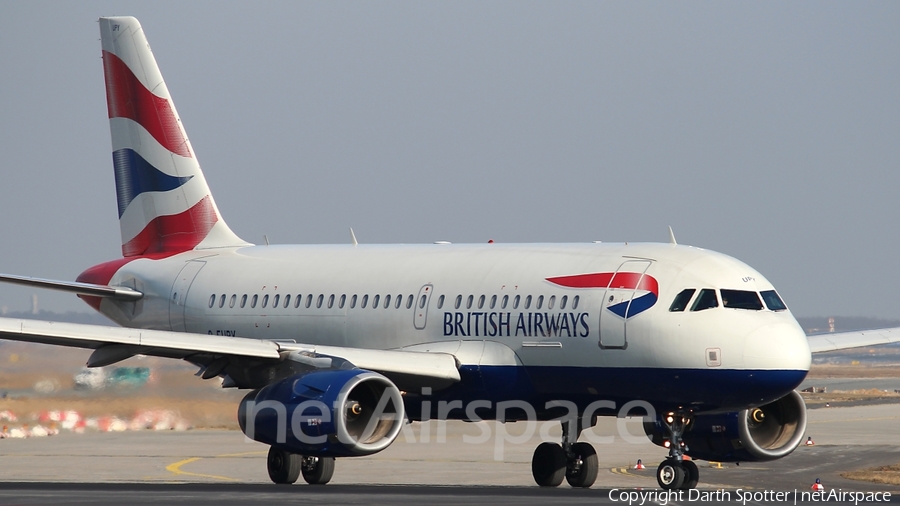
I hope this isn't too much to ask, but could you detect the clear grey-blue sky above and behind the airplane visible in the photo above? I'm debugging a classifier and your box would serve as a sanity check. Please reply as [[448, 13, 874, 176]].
[[0, 0, 900, 319]]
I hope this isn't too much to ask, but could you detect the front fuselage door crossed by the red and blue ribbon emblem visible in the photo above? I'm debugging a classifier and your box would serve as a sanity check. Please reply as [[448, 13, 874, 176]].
[[600, 260, 651, 350]]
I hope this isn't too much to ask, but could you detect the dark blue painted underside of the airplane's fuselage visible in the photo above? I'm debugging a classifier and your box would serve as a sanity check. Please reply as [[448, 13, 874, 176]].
[[405, 366, 807, 420]]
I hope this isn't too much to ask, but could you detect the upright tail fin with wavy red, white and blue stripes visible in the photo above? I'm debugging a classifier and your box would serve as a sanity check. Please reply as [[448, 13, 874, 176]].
[[100, 17, 247, 257]]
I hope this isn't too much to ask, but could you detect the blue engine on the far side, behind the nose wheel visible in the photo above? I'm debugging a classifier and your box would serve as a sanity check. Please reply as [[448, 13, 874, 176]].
[[644, 392, 806, 462]]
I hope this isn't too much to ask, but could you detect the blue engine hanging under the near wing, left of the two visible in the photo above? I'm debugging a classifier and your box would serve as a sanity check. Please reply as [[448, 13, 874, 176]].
[[238, 369, 404, 457]]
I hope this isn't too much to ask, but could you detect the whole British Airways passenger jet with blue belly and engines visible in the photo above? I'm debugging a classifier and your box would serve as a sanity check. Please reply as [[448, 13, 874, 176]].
[[0, 17, 900, 490]]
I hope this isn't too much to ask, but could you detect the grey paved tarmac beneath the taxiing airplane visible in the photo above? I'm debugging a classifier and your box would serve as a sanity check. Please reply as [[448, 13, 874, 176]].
[[0, 404, 900, 504]]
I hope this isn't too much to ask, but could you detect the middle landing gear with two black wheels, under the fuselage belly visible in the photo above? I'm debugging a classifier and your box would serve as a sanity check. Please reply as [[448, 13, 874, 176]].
[[531, 418, 599, 488]]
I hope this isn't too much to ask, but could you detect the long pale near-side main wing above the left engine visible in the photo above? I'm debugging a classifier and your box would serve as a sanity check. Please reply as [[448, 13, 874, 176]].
[[0, 318, 460, 388]]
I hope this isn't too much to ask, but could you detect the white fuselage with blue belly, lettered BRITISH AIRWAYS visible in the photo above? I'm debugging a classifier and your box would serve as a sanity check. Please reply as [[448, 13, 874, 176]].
[[88, 244, 810, 418]]
